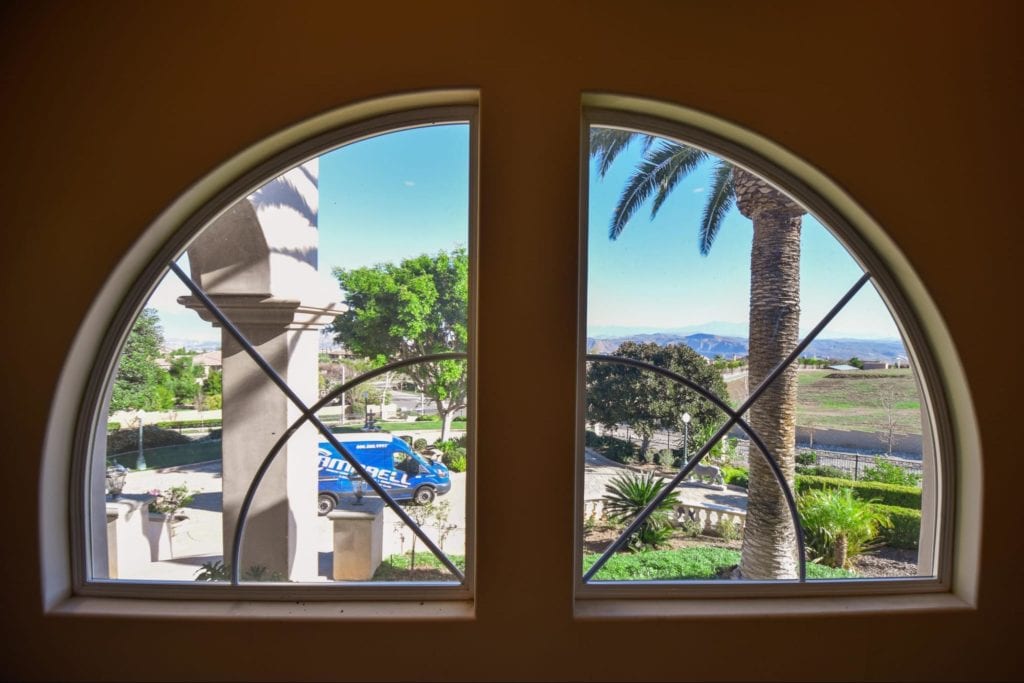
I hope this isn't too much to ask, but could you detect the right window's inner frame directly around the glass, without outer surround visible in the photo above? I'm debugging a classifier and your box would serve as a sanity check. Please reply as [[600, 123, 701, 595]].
[[572, 100, 958, 598]]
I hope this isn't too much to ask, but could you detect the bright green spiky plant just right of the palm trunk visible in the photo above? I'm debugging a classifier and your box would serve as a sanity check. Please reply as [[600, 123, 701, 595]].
[[798, 488, 892, 568]]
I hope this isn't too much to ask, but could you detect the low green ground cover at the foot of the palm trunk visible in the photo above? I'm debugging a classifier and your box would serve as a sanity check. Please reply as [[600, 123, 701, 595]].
[[583, 548, 856, 581]]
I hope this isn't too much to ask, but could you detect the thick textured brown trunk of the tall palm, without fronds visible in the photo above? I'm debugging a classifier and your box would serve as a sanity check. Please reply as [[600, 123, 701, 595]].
[[737, 189, 803, 580]]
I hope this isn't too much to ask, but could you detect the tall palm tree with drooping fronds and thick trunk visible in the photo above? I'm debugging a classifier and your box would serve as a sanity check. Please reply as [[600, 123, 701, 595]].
[[591, 128, 806, 580]]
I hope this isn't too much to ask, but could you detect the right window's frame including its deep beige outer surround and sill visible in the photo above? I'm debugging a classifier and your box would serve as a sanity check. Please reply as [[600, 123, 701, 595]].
[[573, 93, 980, 617]]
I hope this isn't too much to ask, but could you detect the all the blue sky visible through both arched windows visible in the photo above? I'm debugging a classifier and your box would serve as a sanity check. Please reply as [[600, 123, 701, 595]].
[[150, 125, 898, 348]]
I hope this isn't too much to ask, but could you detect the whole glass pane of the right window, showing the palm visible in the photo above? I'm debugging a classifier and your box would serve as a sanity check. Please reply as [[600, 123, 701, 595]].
[[582, 127, 935, 582]]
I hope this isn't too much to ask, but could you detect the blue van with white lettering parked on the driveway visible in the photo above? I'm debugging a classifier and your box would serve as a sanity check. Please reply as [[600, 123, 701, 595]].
[[316, 432, 452, 515]]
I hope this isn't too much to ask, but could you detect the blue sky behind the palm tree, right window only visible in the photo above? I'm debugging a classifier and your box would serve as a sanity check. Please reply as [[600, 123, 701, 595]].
[[587, 136, 899, 338]]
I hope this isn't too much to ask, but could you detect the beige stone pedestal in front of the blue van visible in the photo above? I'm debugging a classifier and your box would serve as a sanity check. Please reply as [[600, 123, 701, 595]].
[[328, 498, 384, 581]]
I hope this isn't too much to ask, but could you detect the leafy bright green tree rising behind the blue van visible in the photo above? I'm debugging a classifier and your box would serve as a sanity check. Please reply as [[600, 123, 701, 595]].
[[332, 249, 469, 439]]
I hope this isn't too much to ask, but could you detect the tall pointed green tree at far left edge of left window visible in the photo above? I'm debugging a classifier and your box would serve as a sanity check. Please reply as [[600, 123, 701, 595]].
[[111, 308, 174, 411]]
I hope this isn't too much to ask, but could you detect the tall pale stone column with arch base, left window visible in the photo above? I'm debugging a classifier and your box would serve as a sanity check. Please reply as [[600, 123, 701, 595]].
[[179, 162, 342, 581]]
